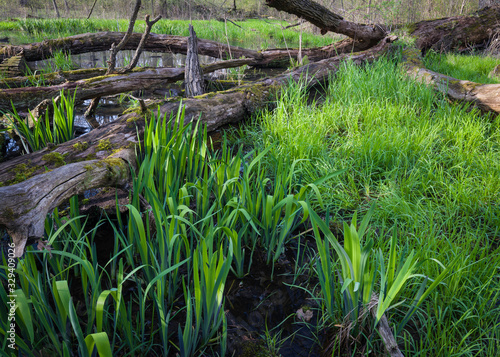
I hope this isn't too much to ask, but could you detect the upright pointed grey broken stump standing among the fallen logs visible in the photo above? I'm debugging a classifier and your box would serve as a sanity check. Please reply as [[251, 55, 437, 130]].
[[184, 24, 205, 97]]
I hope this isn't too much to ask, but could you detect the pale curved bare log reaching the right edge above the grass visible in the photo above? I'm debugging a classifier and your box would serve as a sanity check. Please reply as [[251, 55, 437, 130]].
[[403, 49, 500, 113]]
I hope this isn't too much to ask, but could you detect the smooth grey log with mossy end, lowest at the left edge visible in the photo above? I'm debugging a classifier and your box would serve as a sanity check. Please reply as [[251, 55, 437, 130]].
[[0, 149, 135, 257]]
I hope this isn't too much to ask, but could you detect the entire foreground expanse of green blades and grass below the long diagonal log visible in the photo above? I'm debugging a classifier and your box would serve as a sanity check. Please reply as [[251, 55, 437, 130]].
[[0, 35, 500, 356]]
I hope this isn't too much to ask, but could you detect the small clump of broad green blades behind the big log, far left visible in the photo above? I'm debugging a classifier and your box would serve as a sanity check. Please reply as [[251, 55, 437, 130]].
[[7, 91, 76, 153]]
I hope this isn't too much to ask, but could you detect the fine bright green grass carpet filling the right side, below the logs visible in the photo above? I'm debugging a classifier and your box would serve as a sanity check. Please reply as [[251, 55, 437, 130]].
[[240, 59, 500, 355]]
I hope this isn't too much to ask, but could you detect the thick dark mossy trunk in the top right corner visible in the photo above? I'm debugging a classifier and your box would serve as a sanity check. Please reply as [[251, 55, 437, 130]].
[[409, 6, 500, 52]]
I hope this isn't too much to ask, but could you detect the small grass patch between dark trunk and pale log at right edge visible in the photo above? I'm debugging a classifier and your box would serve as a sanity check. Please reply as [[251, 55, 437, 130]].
[[424, 51, 500, 84]]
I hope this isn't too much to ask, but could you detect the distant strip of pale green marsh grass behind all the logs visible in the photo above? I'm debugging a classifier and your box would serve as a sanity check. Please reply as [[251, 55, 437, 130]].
[[0, 19, 338, 50]]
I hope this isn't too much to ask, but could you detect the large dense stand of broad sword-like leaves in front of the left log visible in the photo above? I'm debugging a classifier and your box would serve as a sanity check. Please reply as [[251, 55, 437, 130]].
[[0, 101, 338, 356]]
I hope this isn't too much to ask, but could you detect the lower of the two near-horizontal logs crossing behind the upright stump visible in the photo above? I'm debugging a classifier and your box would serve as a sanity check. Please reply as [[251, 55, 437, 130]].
[[0, 59, 252, 112]]
